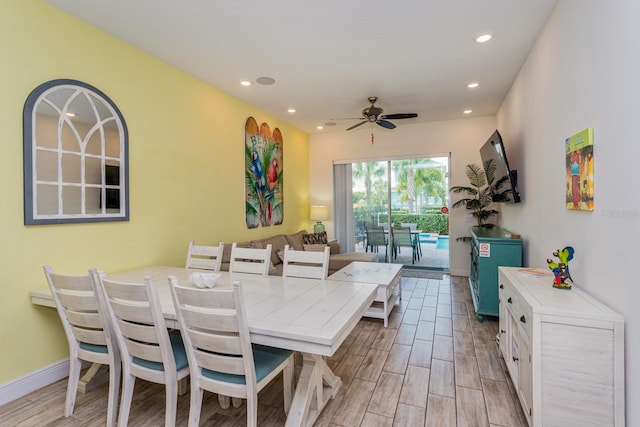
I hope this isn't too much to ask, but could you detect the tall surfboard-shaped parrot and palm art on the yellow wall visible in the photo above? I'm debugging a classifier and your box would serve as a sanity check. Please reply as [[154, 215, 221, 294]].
[[244, 117, 284, 228]]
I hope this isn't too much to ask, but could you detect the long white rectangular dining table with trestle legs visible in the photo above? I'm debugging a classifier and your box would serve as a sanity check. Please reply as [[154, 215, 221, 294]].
[[30, 266, 378, 426]]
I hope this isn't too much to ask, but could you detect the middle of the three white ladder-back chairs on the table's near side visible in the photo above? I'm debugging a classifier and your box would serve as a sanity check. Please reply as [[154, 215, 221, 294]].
[[92, 271, 189, 427]]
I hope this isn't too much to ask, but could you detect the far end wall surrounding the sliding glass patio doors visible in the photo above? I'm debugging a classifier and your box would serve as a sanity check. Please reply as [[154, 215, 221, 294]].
[[309, 116, 500, 276]]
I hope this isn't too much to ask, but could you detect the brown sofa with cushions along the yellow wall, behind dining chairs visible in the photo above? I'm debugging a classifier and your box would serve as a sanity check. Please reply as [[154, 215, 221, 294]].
[[221, 230, 378, 276]]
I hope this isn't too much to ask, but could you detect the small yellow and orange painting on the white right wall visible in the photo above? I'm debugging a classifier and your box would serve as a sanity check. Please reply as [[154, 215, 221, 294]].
[[565, 128, 594, 211]]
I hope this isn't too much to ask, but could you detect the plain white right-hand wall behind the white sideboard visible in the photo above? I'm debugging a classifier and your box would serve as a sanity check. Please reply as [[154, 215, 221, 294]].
[[497, 0, 640, 426]]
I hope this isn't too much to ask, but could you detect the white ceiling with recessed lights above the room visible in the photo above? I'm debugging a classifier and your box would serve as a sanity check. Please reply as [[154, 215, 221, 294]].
[[45, 0, 556, 133]]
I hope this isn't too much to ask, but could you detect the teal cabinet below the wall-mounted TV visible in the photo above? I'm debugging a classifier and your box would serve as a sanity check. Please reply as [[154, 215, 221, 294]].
[[469, 227, 522, 322]]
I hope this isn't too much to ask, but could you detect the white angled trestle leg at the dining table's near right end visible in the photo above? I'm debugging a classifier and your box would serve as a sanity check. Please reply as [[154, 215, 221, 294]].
[[286, 353, 342, 427]]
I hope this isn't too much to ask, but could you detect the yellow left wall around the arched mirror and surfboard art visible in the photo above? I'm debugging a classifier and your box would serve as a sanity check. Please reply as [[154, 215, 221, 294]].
[[0, 0, 309, 383]]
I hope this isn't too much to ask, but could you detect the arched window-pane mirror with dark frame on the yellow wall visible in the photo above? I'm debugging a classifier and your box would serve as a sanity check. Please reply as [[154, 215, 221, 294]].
[[23, 79, 129, 225]]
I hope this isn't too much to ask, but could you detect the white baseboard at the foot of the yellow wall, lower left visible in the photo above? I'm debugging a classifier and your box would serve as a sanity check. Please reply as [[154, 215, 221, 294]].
[[0, 358, 69, 405]]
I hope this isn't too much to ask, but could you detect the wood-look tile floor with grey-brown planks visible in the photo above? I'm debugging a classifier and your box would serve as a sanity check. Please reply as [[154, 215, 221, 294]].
[[0, 275, 527, 427]]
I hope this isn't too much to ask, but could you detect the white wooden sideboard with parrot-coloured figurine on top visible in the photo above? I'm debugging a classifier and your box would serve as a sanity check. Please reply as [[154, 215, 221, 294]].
[[498, 267, 625, 427]]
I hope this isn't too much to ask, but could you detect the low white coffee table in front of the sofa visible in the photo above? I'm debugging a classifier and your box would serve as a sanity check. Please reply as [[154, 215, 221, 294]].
[[327, 261, 402, 328]]
